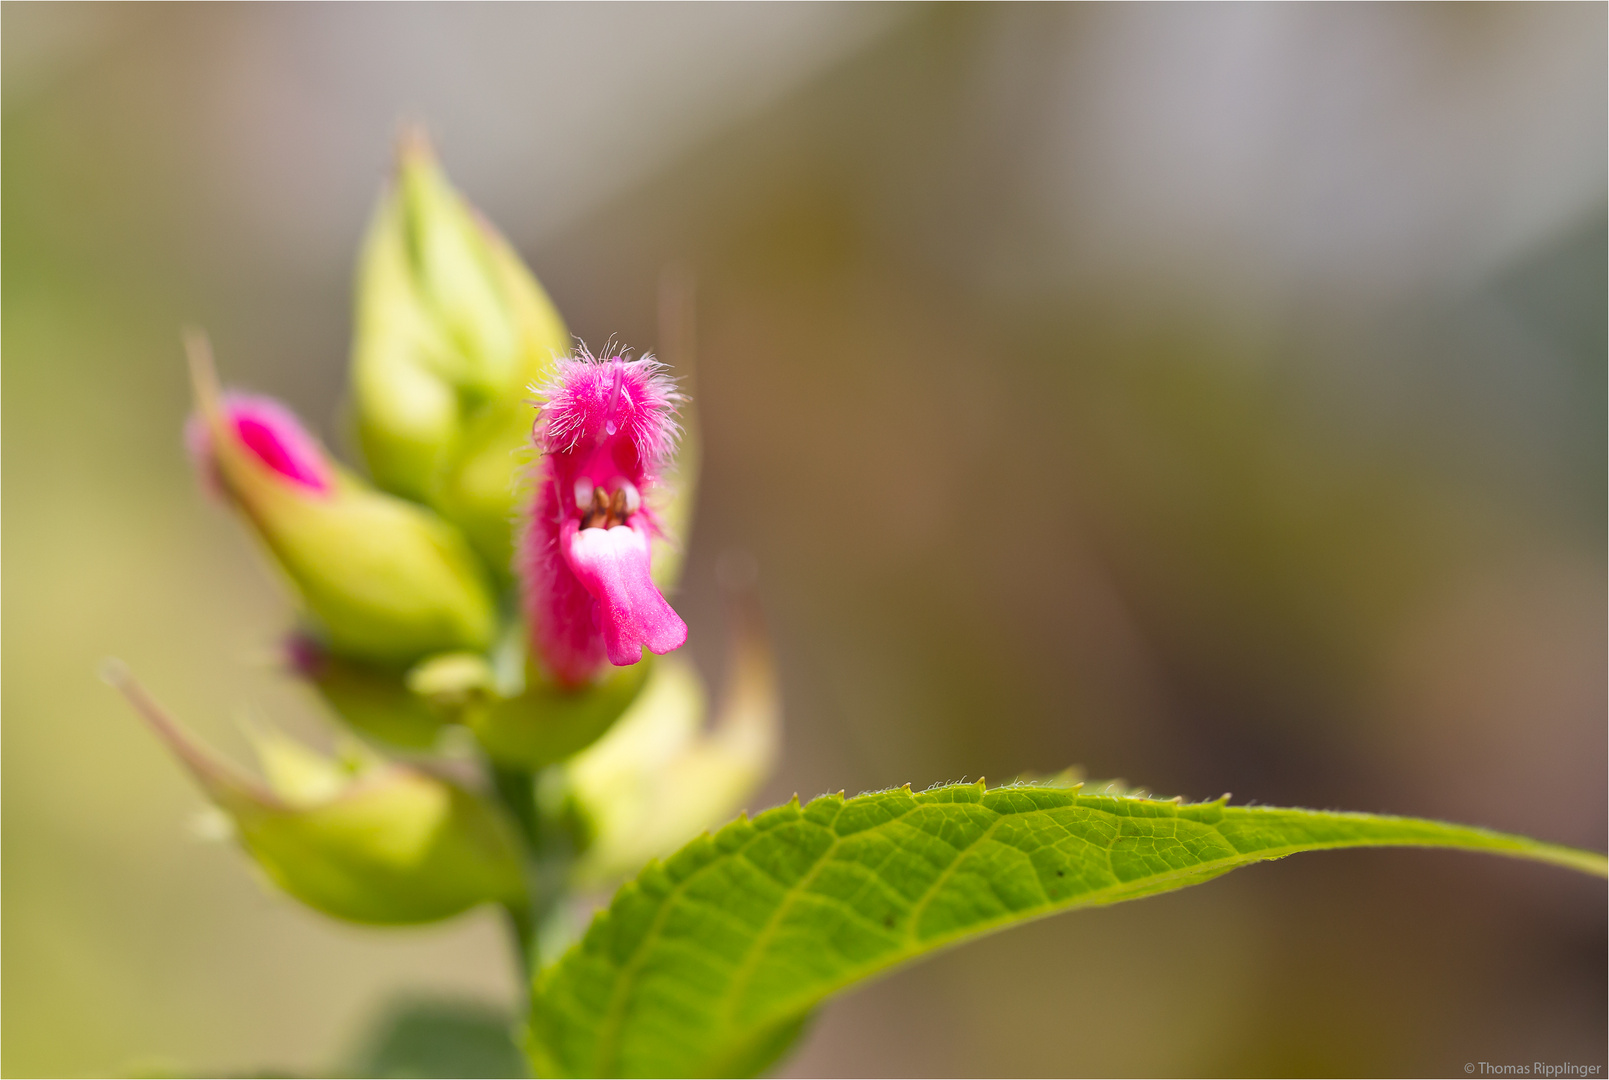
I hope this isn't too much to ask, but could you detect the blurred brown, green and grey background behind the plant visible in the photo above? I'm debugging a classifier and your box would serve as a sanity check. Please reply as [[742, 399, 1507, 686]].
[[0, 3, 1609, 1075]]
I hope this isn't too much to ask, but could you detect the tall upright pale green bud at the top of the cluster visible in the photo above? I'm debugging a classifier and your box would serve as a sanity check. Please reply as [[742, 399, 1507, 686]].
[[352, 132, 568, 573]]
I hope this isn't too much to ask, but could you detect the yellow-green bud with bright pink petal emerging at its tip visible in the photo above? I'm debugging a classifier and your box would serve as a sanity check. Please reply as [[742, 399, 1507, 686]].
[[187, 336, 497, 665]]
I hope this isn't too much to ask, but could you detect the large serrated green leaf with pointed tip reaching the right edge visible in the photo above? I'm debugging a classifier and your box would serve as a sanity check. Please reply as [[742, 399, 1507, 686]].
[[529, 781, 1609, 1077]]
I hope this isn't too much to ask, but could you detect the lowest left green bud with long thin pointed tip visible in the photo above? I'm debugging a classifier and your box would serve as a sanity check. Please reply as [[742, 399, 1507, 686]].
[[105, 665, 526, 924]]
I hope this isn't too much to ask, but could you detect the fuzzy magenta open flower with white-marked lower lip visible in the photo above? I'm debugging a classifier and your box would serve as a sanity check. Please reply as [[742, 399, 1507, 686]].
[[518, 348, 687, 686]]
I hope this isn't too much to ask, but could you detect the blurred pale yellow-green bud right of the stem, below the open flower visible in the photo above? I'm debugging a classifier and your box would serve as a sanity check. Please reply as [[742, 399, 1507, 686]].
[[565, 598, 782, 887]]
